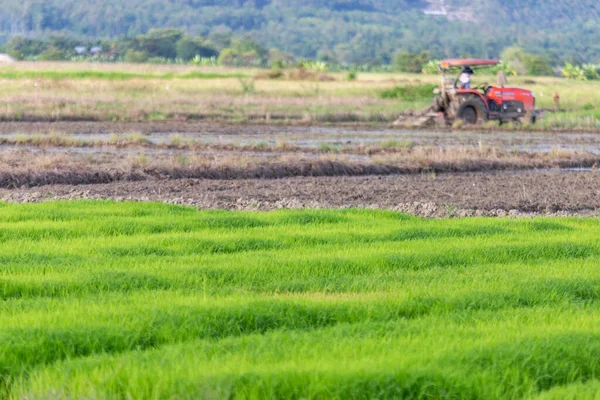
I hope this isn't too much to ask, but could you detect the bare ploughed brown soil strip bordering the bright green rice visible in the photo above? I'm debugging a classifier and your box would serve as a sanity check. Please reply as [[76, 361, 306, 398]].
[[0, 171, 600, 217]]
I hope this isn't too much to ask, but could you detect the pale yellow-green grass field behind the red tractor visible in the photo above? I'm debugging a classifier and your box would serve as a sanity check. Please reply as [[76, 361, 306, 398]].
[[0, 63, 600, 126]]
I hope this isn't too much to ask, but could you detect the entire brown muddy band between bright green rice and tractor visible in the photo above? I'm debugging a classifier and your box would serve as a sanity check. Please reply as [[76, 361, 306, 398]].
[[0, 123, 600, 217]]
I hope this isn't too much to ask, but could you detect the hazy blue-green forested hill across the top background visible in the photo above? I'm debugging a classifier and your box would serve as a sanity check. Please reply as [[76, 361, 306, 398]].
[[0, 0, 600, 63]]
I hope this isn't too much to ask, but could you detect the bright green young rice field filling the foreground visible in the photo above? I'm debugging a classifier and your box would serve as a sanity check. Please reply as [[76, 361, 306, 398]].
[[0, 202, 600, 399]]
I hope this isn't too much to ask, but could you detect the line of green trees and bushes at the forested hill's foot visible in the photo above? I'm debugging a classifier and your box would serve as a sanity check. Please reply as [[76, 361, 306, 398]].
[[0, 29, 600, 80]]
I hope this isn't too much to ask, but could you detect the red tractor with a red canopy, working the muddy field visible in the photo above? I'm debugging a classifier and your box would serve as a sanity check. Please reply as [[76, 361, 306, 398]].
[[432, 59, 538, 125]]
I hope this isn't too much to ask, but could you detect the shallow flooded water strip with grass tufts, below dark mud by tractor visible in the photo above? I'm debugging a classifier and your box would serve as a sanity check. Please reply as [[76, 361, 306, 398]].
[[0, 126, 600, 156]]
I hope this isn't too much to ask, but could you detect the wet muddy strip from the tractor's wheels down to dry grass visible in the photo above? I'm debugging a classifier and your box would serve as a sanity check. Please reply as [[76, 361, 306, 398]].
[[0, 121, 600, 154]]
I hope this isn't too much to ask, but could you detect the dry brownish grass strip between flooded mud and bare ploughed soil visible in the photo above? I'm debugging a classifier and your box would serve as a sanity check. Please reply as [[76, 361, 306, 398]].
[[0, 144, 600, 188]]
